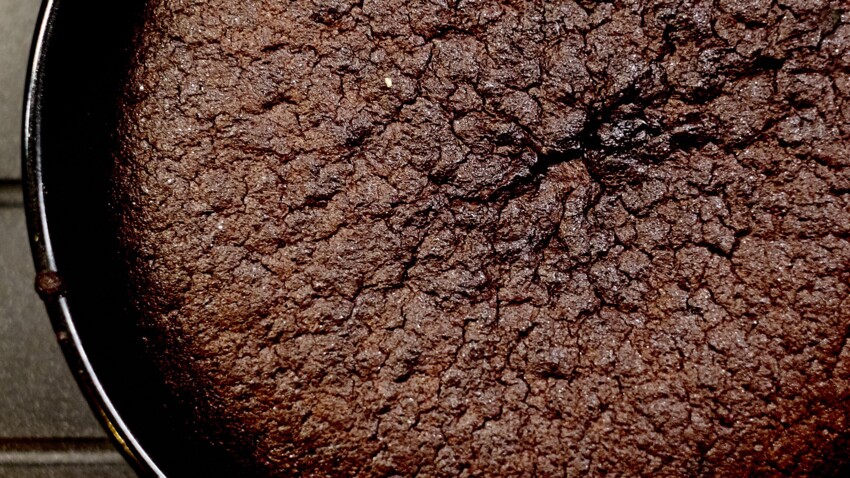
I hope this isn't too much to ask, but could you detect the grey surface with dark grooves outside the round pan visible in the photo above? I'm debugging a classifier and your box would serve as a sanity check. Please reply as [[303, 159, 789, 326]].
[[0, 0, 135, 478]]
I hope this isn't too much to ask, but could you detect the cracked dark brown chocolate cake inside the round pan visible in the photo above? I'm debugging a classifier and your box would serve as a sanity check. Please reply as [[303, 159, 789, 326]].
[[114, 0, 850, 477]]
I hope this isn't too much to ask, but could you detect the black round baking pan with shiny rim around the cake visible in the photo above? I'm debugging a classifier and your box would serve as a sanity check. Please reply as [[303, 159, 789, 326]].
[[24, 0, 252, 477]]
